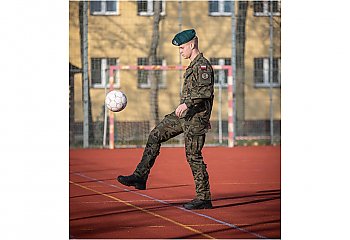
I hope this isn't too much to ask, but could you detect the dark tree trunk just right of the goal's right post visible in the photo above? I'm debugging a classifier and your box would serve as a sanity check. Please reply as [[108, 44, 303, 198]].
[[236, 1, 248, 135]]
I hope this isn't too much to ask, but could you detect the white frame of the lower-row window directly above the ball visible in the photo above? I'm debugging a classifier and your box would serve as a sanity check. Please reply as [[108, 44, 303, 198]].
[[90, 57, 120, 88]]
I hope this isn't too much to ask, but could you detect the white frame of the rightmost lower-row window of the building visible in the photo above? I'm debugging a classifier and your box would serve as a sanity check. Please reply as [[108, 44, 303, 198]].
[[253, 57, 281, 88]]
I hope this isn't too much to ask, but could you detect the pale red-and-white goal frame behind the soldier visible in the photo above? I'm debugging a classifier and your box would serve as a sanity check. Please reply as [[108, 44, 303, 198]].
[[104, 65, 235, 149]]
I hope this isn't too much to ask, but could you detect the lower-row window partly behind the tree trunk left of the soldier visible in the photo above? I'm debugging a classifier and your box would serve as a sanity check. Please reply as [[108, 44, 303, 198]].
[[137, 58, 166, 88]]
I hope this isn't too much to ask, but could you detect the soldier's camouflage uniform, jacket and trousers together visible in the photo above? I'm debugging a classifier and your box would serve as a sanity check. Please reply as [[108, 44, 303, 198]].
[[134, 53, 214, 200]]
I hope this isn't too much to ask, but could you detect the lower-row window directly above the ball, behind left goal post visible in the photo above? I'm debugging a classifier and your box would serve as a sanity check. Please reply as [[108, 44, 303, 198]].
[[91, 58, 120, 88]]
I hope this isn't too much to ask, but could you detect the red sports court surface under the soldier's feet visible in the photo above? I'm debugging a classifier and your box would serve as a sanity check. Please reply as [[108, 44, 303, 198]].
[[69, 146, 281, 239]]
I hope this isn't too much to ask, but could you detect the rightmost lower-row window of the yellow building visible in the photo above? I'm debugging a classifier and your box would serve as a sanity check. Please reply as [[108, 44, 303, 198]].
[[254, 58, 281, 87]]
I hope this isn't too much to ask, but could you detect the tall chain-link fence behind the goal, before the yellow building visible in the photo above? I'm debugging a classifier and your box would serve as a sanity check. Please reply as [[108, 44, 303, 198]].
[[69, 0, 281, 147]]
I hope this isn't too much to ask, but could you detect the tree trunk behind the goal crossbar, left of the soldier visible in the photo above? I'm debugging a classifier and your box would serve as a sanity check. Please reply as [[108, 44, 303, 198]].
[[149, 1, 161, 129]]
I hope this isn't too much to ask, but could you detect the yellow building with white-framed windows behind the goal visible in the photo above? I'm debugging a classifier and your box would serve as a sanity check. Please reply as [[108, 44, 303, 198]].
[[69, 0, 281, 144]]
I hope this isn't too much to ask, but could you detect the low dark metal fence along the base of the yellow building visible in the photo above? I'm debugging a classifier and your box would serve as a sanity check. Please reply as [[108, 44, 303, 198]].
[[69, 113, 281, 148]]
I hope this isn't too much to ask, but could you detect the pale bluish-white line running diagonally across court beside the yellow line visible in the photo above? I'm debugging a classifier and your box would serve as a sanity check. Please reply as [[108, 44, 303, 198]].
[[74, 173, 267, 239]]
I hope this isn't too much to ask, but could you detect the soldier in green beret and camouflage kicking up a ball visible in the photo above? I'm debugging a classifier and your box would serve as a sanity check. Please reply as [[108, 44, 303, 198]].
[[117, 29, 214, 209]]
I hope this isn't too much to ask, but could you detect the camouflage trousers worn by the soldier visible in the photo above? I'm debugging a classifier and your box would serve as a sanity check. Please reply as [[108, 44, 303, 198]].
[[134, 112, 211, 200]]
